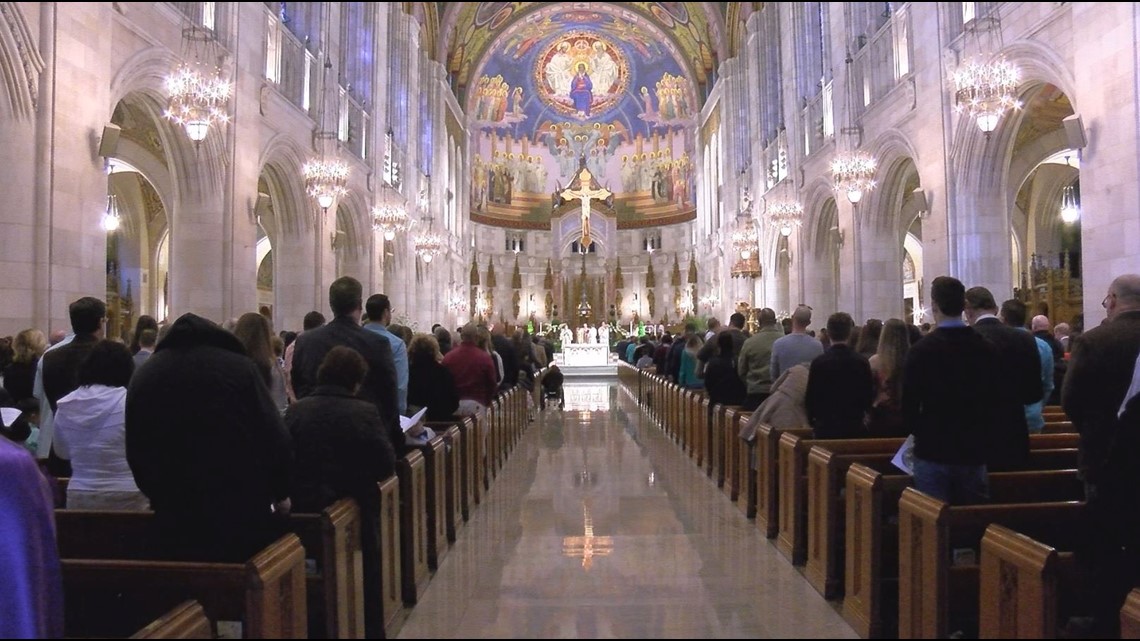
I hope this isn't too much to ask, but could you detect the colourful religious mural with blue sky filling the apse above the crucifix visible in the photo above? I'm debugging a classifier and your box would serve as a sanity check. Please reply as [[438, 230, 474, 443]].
[[461, 2, 703, 229]]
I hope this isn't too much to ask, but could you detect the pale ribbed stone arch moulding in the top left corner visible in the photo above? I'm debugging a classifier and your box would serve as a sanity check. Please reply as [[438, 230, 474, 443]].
[[0, 2, 44, 121]]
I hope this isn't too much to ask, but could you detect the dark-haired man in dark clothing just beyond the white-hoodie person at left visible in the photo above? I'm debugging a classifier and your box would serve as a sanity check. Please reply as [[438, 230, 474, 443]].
[[34, 297, 107, 477]]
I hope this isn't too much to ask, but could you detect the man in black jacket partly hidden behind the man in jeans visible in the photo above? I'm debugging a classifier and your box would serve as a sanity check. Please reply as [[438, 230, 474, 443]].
[[966, 287, 1044, 472]]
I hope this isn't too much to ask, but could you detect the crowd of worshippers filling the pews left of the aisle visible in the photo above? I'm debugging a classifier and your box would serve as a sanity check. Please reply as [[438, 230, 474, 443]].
[[0, 277, 553, 638]]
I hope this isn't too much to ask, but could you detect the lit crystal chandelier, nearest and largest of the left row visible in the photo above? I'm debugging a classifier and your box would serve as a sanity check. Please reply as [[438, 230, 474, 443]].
[[163, 26, 234, 144]]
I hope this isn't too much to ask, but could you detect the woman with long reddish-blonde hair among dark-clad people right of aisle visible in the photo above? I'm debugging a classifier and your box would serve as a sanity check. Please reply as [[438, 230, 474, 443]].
[[864, 318, 911, 437]]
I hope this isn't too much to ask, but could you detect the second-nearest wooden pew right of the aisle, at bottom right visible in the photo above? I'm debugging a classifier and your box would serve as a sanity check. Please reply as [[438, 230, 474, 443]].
[[978, 518, 1094, 639]]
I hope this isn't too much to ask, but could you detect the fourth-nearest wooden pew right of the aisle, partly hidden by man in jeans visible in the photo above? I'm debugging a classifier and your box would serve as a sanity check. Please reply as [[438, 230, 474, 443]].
[[842, 442, 1083, 638]]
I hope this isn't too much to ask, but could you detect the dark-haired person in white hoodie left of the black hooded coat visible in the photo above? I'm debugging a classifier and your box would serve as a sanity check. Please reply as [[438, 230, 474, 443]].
[[54, 340, 150, 510]]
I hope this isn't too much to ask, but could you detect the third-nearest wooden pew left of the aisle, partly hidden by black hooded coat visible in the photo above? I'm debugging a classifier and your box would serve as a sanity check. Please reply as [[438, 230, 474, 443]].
[[56, 498, 364, 639]]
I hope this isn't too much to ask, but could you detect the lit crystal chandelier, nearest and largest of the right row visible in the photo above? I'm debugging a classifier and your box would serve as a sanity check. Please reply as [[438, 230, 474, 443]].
[[954, 57, 1021, 136]]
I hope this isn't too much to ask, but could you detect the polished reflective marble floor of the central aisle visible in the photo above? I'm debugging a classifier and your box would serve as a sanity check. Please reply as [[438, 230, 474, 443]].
[[399, 378, 856, 639]]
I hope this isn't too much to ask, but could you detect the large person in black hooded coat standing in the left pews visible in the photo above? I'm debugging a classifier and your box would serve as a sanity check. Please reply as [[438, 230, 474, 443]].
[[127, 314, 293, 562]]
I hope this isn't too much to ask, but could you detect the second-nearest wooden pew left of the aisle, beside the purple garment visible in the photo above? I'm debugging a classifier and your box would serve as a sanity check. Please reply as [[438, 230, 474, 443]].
[[60, 534, 307, 639]]
